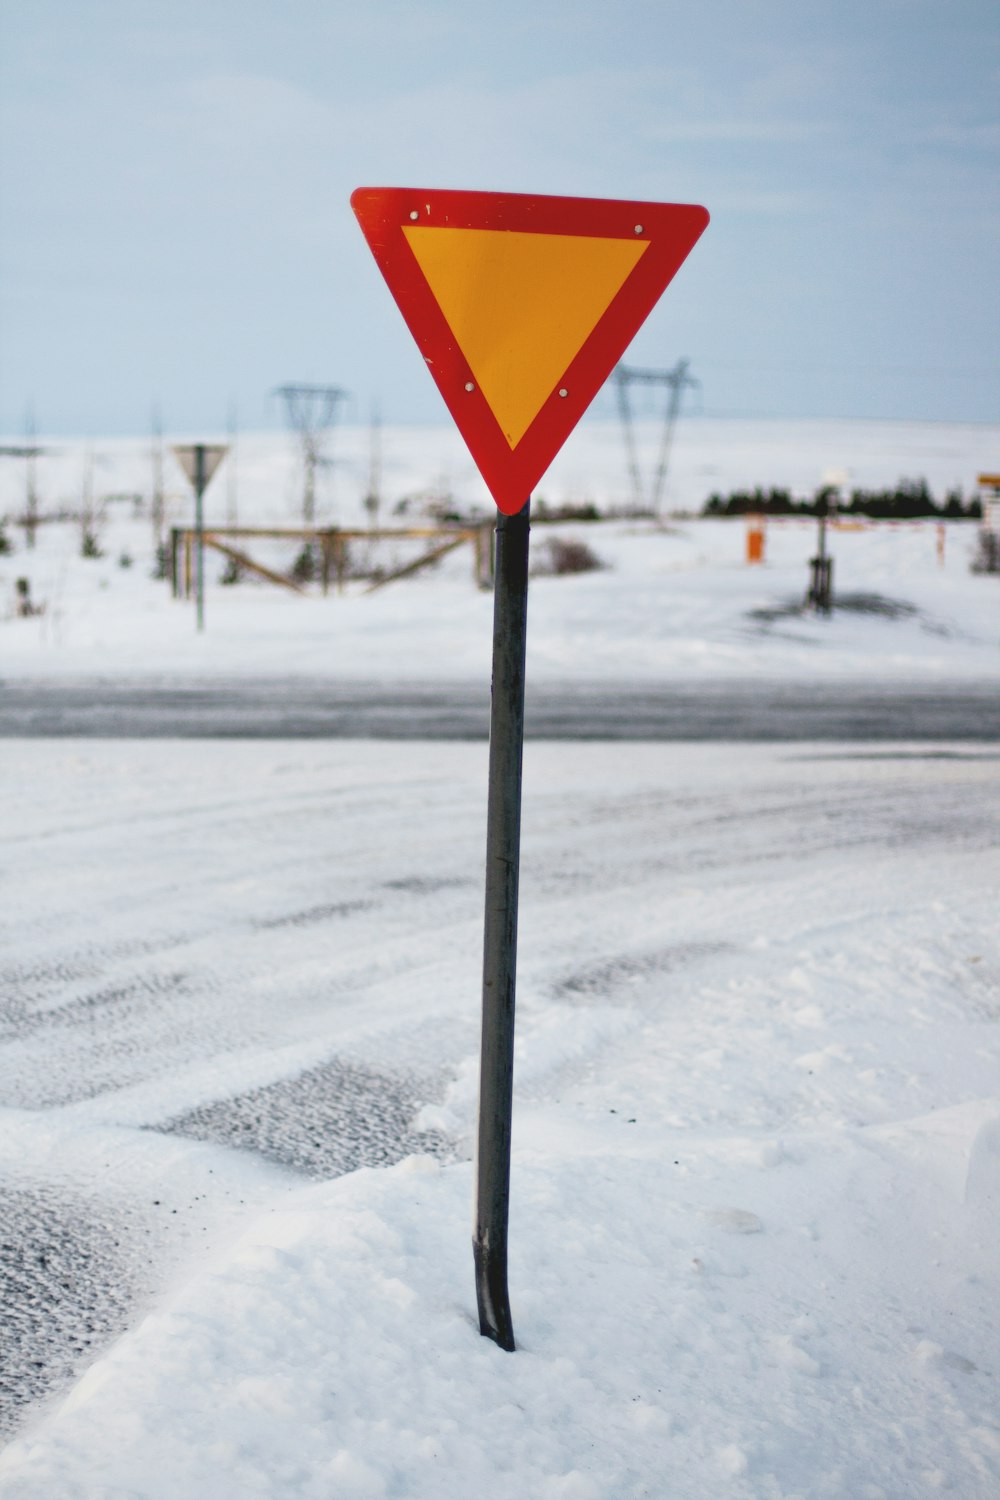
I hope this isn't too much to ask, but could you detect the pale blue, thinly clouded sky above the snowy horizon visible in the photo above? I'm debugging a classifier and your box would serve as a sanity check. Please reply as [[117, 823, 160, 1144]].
[[0, 0, 1000, 435]]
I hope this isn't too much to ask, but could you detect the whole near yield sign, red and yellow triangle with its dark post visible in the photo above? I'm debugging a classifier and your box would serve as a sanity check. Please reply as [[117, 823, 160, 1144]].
[[351, 188, 708, 1350]]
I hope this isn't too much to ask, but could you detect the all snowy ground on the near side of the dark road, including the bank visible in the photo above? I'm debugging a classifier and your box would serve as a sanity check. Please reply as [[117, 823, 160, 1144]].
[[0, 741, 1000, 1500]]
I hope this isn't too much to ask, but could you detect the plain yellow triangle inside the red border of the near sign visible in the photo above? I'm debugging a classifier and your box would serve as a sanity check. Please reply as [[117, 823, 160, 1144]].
[[403, 225, 649, 449]]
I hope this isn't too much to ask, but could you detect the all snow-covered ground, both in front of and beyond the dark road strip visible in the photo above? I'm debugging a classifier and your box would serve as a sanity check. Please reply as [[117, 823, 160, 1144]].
[[0, 420, 1000, 1500]]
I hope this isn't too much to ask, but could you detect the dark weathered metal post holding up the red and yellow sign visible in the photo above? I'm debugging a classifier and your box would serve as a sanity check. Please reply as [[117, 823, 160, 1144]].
[[472, 503, 531, 1350]]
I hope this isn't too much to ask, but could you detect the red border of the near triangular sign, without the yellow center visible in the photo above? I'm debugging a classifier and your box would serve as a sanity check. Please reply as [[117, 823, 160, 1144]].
[[351, 188, 709, 515]]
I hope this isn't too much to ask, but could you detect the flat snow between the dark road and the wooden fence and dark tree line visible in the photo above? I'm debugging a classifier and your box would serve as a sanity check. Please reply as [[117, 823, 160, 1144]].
[[0, 519, 1000, 684]]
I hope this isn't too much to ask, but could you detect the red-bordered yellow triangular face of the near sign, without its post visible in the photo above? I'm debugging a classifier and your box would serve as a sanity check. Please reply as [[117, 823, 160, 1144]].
[[351, 188, 708, 516]]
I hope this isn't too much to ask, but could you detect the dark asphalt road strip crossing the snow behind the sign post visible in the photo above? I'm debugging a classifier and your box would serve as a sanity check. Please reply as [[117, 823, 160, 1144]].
[[0, 680, 1000, 741]]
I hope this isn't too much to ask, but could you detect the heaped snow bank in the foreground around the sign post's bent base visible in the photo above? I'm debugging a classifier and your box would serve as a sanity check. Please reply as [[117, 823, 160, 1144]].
[[0, 1101, 1000, 1500]]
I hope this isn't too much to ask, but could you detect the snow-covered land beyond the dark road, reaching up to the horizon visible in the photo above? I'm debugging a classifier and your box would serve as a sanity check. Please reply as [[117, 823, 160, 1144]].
[[0, 422, 1000, 683]]
